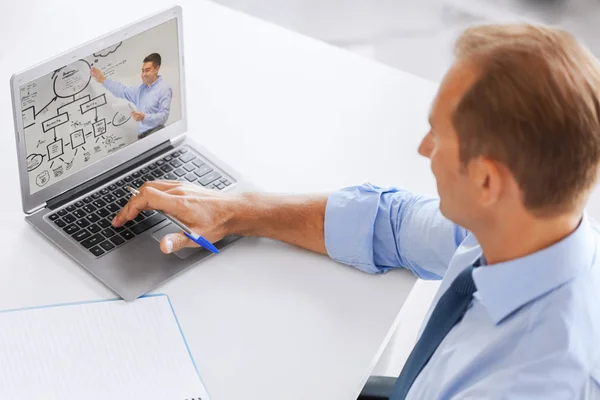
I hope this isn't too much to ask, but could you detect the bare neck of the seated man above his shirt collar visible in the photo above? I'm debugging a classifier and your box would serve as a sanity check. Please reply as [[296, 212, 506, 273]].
[[472, 214, 581, 264]]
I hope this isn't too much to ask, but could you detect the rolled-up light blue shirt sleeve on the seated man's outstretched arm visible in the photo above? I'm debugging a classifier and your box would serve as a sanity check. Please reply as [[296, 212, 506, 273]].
[[325, 184, 468, 279]]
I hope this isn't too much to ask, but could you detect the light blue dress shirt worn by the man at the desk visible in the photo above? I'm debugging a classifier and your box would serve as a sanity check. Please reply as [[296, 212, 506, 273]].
[[325, 184, 600, 400]]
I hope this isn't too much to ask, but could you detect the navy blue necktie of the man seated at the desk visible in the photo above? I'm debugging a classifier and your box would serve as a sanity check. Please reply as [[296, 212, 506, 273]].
[[390, 260, 480, 400]]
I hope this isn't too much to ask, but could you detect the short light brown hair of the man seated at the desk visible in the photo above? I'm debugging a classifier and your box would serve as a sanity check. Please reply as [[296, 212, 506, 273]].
[[453, 24, 600, 216]]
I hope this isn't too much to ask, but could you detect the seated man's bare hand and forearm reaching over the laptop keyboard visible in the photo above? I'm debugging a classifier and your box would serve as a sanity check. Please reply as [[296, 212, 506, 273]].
[[113, 181, 328, 254]]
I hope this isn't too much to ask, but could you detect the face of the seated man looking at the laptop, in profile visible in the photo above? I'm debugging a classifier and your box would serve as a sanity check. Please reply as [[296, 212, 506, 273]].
[[419, 62, 478, 226]]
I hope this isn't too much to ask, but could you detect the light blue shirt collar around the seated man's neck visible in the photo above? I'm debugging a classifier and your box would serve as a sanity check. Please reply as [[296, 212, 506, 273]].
[[473, 215, 596, 324]]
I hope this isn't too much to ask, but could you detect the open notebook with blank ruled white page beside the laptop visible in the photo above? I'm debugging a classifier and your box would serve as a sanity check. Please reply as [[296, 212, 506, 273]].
[[0, 295, 209, 400]]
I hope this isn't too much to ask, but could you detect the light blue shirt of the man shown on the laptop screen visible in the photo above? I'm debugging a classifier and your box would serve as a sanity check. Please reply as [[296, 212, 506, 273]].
[[103, 76, 173, 135]]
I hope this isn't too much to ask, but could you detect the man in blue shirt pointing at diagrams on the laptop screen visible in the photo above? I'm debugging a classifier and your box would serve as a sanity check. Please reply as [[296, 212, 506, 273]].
[[90, 53, 173, 139]]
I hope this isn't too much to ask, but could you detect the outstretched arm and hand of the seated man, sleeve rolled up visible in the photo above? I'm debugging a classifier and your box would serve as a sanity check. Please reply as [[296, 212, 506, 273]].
[[115, 181, 467, 279]]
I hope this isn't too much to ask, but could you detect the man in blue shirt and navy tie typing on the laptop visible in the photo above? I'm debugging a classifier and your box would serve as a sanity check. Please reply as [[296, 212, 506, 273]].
[[114, 25, 600, 400]]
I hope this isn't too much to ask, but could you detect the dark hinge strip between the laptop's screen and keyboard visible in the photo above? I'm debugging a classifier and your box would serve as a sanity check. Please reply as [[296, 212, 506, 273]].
[[46, 141, 173, 210]]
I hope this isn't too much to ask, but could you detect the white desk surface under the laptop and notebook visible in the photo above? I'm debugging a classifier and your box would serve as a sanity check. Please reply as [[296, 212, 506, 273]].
[[0, 0, 436, 400]]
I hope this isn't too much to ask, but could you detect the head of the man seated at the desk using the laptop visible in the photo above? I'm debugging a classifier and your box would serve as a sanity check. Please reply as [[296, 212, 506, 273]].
[[419, 25, 600, 229]]
